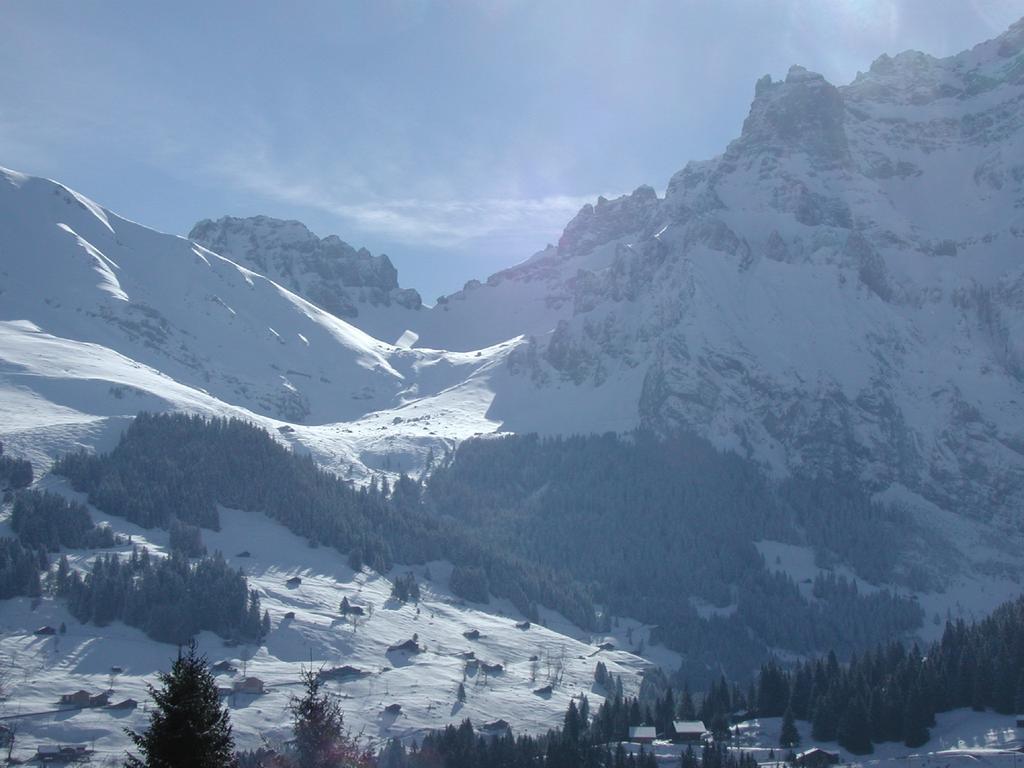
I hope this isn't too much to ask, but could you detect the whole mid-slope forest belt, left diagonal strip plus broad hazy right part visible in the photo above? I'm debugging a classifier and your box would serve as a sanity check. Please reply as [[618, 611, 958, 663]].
[[46, 414, 927, 683]]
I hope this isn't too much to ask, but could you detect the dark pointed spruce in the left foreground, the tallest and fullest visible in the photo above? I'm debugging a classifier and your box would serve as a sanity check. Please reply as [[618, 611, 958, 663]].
[[126, 641, 237, 768]]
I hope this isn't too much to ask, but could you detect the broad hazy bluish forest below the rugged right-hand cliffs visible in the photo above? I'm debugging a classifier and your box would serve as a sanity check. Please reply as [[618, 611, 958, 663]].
[[425, 432, 926, 683]]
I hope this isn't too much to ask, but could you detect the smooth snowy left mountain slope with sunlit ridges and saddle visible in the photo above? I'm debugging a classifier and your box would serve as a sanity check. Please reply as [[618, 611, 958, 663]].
[[0, 170, 512, 476]]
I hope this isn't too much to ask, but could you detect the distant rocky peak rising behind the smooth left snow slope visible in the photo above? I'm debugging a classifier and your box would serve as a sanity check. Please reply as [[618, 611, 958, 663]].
[[188, 216, 423, 341]]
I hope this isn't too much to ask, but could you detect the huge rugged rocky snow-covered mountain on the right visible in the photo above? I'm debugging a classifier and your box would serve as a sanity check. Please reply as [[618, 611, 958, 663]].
[[416, 22, 1024, 522]]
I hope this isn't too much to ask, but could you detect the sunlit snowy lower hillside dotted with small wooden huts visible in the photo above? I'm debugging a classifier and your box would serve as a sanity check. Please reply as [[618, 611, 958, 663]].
[[0, 478, 655, 758]]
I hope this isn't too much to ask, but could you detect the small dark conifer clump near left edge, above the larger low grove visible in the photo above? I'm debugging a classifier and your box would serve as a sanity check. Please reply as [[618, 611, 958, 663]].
[[10, 490, 117, 552]]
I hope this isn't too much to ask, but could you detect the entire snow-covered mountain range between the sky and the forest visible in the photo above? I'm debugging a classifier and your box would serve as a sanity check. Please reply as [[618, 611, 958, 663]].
[[0, 22, 1024, 638]]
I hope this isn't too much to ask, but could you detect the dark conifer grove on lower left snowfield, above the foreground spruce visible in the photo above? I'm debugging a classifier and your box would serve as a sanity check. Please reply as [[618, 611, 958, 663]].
[[55, 548, 270, 644]]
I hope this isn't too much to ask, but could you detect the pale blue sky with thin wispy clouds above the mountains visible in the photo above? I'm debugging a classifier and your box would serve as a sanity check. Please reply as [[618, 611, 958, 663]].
[[0, 0, 1024, 303]]
